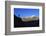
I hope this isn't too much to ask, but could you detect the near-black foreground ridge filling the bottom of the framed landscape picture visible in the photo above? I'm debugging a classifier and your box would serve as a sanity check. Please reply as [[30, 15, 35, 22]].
[[14, 15, 39, 28]]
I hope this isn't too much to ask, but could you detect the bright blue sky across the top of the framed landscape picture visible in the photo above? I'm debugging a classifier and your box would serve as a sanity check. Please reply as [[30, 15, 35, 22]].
[[14, 8, 39, 17]]
